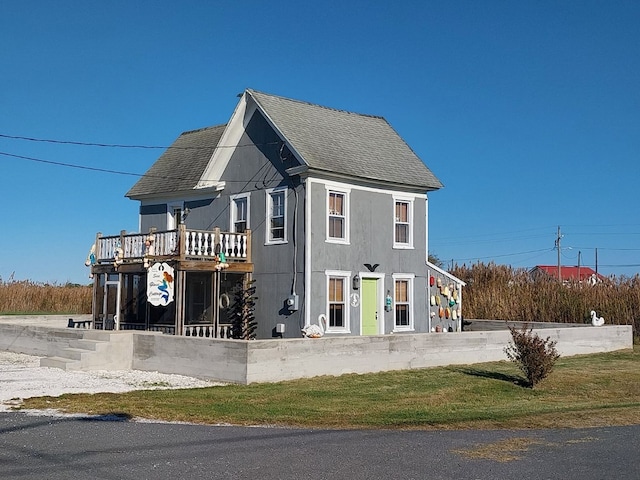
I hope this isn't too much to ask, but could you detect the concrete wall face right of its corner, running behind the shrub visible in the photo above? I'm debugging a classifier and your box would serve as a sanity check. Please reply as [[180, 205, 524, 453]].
[[247, 326, 633, 383]]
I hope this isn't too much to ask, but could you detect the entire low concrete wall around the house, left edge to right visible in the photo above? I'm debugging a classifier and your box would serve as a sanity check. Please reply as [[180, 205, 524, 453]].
[[0, 322, 633, 384]]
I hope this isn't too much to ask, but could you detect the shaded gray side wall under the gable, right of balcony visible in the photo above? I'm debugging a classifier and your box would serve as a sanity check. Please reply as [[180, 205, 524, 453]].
[[219, 113, 305, 338]]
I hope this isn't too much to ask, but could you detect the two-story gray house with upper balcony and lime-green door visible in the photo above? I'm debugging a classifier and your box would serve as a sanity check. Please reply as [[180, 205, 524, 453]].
[[92, 90, 462, 338]]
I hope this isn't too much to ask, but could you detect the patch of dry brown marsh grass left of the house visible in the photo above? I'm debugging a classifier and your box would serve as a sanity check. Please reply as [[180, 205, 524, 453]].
[[0, 278, 92, 314]]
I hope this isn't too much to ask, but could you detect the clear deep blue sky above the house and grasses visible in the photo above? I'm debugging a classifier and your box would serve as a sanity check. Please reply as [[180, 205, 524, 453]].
[[0, 0, 640, 283]]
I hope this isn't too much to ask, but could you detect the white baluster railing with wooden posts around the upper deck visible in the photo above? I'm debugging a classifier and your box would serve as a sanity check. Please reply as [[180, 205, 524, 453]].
[[95, 225, 251, 264]]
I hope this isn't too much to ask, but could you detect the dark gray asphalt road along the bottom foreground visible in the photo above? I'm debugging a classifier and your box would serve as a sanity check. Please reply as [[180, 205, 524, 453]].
[[0, 413, 640, 480]]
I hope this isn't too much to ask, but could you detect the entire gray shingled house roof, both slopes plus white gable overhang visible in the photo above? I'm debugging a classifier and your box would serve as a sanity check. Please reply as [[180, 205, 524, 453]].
[[126, 89, 442, 199]]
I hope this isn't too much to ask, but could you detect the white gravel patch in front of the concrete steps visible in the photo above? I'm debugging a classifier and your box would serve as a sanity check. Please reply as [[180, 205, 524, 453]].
[[0, 352, 224, 412]]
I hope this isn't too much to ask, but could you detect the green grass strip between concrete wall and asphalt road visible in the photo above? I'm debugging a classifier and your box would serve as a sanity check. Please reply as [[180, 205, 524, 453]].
[[22, 347, 640, 429]]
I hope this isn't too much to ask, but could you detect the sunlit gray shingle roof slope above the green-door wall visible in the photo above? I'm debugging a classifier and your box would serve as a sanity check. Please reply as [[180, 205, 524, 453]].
[[247, 90, 443, 190]]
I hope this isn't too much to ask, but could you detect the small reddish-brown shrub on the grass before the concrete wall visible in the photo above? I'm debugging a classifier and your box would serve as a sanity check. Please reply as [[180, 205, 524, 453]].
[[504, 323, 560, 388]]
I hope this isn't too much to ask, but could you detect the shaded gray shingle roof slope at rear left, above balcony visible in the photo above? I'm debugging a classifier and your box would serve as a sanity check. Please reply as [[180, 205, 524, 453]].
[[126, 125, 226, 199]]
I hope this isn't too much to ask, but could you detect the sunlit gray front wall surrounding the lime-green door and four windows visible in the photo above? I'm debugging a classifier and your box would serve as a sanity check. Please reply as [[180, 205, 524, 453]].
[[309, 181, 428, 335]]
